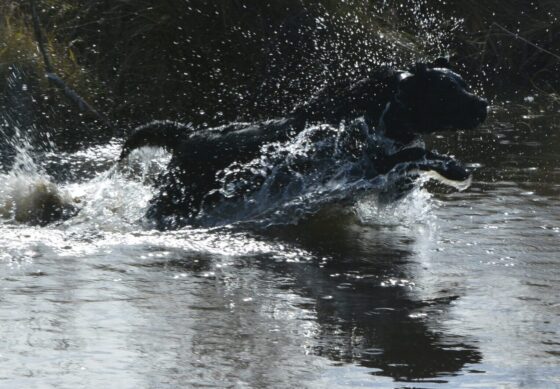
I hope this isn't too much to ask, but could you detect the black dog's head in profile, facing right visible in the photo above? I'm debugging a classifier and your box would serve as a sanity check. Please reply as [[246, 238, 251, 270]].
[[394, 58, 488, 134]]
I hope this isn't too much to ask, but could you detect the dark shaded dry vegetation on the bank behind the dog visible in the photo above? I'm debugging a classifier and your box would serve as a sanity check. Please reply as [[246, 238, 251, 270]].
[[0, 0, 560, 130]]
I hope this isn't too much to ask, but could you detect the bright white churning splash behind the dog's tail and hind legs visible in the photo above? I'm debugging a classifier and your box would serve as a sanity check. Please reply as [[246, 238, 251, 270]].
[[0, 121, 164, 230]]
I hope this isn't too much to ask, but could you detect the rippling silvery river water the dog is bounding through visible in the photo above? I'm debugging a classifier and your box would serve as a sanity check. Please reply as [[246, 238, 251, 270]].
[[0, 96, 560, 388]]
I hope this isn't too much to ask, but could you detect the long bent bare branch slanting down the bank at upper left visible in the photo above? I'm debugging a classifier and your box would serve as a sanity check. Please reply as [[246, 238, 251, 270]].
[[29, 0, 111, 127]]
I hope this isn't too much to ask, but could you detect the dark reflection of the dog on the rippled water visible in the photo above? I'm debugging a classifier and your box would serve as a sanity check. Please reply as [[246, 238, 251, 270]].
[[264, 215, 480, 381]]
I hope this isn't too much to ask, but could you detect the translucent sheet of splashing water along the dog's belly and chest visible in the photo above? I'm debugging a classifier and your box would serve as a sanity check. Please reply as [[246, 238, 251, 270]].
[[188, 119, 446, 227]]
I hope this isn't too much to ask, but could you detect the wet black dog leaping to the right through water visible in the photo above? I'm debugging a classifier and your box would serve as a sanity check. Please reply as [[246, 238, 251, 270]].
[[120, 59, 488, 228]]
